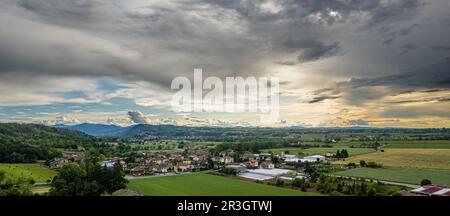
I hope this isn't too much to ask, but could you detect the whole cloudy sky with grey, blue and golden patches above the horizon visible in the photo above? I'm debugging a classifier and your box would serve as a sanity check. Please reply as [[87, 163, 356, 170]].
[[0, 0, 450, 128]]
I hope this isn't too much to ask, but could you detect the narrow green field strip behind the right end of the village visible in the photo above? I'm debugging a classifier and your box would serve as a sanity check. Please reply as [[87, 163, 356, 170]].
[[263, 146, 375, 156]]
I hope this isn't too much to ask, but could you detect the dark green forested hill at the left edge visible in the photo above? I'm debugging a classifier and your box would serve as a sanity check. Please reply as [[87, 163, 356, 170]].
[[0, 123, 95, 163]]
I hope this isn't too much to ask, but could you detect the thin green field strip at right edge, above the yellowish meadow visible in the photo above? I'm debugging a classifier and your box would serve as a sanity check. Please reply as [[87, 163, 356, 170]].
[[381, 140, 450, 149]]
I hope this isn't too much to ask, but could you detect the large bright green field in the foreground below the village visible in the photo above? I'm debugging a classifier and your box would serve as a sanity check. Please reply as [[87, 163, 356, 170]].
[[128, 173, 315, 196]]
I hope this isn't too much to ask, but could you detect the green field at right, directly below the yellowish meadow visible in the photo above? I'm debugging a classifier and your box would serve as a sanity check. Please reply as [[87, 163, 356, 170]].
[[335, 167, 450, 185]]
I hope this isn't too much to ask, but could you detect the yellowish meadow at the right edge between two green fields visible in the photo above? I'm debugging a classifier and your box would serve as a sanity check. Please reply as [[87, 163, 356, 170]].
[[333, 148, 450, 171]]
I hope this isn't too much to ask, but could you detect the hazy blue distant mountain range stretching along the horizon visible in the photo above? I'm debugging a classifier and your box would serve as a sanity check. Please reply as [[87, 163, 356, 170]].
[[54, 123, 448, 140]]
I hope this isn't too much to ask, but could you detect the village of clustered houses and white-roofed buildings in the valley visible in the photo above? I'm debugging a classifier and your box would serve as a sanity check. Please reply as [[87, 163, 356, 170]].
[[49, 145, 334, 181]]
